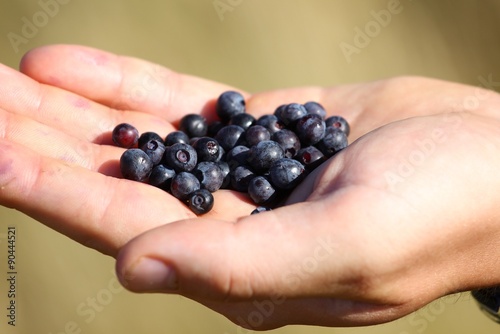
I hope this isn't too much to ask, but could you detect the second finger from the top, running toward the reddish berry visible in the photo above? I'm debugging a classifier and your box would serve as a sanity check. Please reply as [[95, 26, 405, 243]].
[[0, 64, 174, 144]]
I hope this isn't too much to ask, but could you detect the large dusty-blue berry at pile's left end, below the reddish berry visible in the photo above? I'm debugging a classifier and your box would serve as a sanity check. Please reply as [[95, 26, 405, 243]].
[[120, 148, 153, 182]]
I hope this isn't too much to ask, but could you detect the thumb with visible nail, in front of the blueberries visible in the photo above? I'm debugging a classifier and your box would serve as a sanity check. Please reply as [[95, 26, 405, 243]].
[[117, 202, 348, 301]]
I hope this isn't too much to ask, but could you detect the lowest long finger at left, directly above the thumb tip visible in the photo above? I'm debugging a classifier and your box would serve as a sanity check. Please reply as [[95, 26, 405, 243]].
[[0, 140, 251, 255]]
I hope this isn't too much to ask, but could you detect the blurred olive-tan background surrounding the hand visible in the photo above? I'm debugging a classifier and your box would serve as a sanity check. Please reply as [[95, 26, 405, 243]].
[[0, 0, 500, 334]]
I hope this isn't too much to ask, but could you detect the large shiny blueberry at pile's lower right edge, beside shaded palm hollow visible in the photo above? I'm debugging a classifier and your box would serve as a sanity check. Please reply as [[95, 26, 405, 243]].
[[269, 158, 305, 190]]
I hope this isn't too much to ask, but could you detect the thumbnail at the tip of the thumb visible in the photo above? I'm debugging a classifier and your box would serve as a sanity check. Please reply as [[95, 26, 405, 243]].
[[122, 257, 178, 292]]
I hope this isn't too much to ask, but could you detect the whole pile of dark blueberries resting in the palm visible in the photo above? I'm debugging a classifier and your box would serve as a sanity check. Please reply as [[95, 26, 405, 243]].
[[112, 91, 349, 214]]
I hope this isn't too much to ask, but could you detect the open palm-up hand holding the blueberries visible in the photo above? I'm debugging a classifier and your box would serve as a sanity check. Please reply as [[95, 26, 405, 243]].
[[0, 46, 500, 329]]
